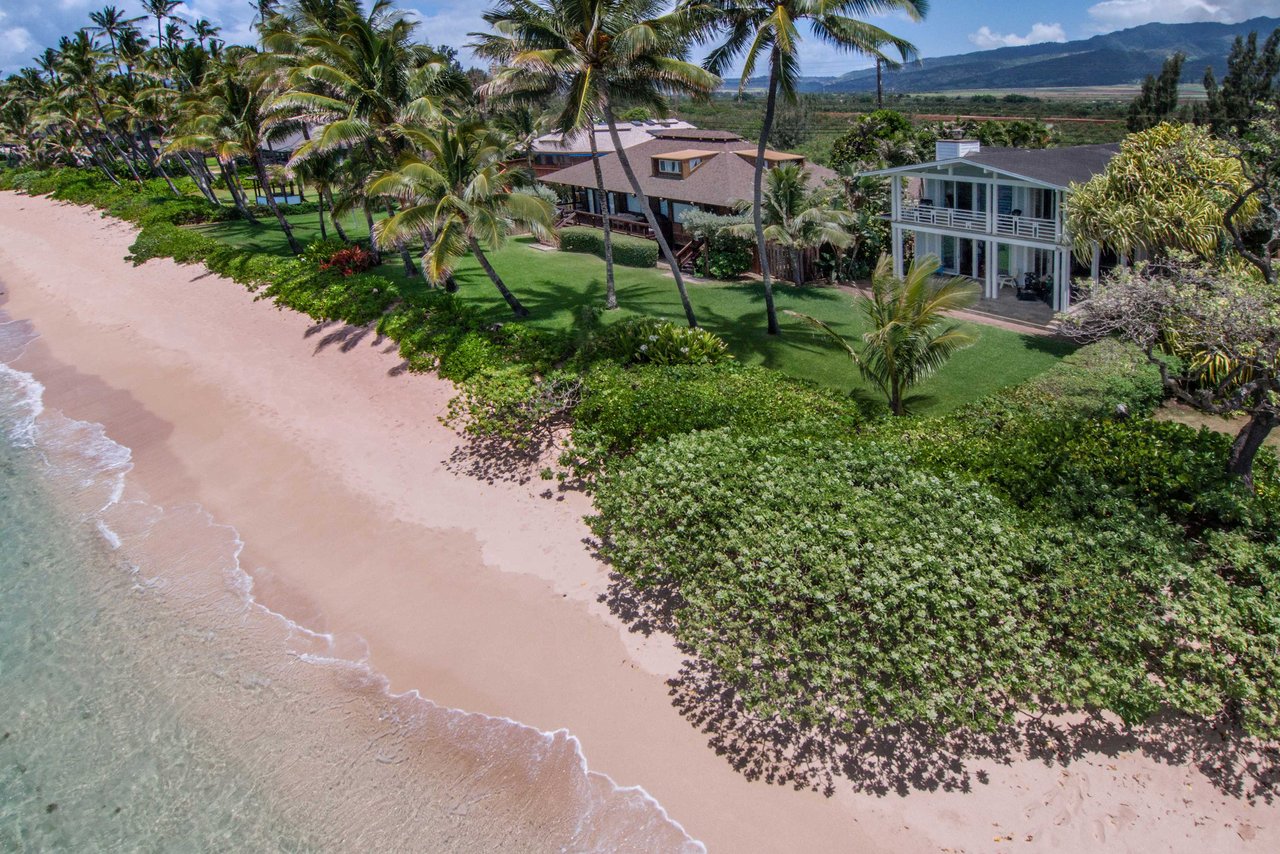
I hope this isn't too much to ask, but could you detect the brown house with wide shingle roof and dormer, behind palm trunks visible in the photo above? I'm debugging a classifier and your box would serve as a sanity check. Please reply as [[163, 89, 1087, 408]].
[[540, 127, 836, 268]]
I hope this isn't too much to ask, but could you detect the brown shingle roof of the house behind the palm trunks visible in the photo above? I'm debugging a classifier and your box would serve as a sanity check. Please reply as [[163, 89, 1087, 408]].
[[541, 131, 836, 207]]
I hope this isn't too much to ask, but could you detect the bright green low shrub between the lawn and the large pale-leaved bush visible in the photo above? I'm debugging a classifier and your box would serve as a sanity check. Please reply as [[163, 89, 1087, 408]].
[[572, 362, 859, 474]]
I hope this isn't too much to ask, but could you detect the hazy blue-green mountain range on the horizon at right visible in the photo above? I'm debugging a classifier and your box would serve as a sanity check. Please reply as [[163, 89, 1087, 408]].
[[768, 18, 1280, 92]]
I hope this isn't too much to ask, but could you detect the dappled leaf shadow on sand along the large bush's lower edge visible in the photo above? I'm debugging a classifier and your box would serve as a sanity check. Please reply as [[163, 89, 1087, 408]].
[[590, 571, 1280, 803]]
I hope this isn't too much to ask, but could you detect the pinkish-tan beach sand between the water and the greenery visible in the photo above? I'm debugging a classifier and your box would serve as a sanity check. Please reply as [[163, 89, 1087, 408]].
[[0, 193, 1280, 851]]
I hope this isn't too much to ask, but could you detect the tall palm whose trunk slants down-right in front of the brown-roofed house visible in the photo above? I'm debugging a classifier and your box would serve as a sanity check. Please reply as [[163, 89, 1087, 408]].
[[471, 0, 719, 326]]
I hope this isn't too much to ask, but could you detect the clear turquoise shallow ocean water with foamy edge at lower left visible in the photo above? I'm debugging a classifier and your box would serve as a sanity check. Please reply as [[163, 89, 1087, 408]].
[[0, 316, 701, 851]]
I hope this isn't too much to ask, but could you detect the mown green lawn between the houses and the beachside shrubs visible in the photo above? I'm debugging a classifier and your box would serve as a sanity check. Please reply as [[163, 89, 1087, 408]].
[[198, 214, 1071, 412]]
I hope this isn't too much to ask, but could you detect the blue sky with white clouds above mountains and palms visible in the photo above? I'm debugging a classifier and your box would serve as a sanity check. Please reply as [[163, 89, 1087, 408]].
[[0, 0, 1280, 76]]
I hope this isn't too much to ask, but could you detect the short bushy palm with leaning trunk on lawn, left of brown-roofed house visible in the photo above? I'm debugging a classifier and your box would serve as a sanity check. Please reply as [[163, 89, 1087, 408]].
[[367, 118, 554, 318]]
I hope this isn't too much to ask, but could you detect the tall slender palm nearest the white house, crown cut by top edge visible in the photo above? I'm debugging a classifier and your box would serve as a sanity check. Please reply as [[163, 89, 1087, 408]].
[[677, 0, 928, 335]]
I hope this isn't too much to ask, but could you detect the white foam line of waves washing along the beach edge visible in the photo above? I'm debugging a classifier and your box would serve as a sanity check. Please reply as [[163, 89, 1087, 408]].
[[0, 308, 705, 851]]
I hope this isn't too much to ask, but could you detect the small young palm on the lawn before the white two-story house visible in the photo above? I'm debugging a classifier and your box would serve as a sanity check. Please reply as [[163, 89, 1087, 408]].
[[787, 255, 978, 415]]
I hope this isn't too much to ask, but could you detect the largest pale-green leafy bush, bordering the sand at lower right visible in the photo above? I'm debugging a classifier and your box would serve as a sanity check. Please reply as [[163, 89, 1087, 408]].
[[590, 428, 1280, 737]]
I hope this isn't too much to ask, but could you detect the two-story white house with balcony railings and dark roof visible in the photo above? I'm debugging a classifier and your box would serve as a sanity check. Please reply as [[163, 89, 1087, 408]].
[[865, 140, 1120, 311]]
